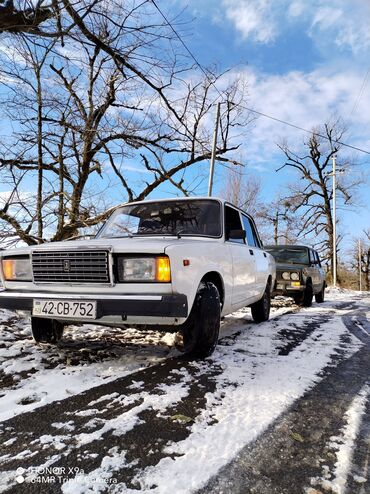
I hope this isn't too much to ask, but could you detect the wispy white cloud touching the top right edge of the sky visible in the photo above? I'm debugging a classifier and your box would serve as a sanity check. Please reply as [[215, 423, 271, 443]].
[[218, 0, 370, 53]]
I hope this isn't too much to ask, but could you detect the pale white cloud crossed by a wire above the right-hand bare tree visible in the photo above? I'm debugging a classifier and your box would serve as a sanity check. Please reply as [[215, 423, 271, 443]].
[[228, 68, 370, 170]]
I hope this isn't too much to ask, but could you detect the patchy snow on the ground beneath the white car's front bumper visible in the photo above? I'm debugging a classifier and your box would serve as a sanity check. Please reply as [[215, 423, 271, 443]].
[[0, 309, 173, 421]]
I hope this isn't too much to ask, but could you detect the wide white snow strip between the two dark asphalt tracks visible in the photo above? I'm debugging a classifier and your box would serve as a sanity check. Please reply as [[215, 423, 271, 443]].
[[127, 308, 361, 494]]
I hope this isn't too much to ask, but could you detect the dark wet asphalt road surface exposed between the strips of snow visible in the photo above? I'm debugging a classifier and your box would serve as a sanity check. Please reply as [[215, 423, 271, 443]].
[[0, 298, 370, 494]]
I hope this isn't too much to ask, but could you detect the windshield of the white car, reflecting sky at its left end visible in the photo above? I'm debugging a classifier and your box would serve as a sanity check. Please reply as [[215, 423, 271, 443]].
[[98, 199, 221, 238]]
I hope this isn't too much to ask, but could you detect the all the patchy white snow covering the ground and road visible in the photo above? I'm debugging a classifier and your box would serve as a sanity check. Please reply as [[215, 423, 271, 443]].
[[0, 290, 370, 494]]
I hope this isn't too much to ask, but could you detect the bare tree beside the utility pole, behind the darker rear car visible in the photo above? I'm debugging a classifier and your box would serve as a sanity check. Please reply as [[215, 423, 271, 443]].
[[279, 121, 361, 278]]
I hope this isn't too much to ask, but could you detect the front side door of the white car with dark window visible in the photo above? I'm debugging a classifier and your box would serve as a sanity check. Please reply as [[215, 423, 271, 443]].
[[225, 204, 256, 308]]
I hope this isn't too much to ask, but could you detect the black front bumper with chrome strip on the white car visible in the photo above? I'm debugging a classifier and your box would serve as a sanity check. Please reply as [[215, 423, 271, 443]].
[[0, 290, 188, 322]]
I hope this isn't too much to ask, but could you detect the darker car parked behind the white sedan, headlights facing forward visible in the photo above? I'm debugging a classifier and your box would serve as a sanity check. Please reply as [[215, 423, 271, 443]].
[[266, 245, 326, 307]]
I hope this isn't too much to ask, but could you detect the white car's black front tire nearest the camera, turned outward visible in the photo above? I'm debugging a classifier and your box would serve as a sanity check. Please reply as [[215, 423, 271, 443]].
[[177, 281, 221, 359]]
